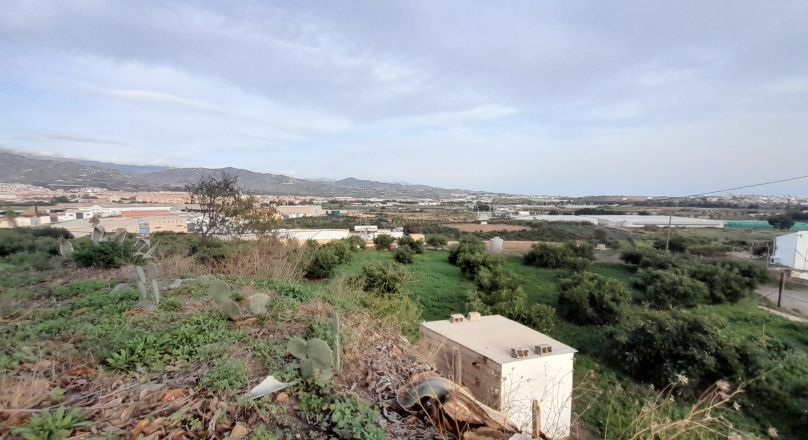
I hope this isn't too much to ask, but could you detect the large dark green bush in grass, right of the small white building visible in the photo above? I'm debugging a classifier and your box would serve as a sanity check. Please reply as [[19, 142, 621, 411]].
[[610, 312, 743, 388]]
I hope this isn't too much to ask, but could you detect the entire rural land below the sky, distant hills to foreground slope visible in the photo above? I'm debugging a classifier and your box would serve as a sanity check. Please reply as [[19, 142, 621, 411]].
[[0, 153, 808, 440]]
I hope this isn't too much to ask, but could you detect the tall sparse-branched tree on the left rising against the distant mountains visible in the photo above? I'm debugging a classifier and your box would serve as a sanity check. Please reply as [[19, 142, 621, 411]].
[[185, 171, 243, 247]]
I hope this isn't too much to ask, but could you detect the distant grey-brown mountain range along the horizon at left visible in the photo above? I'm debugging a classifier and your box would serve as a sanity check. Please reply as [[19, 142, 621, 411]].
[[0, 151, 479, 198]]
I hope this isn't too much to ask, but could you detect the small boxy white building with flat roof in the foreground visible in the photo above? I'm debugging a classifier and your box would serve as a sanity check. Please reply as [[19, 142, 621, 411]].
[[421, 313, 576, 439]]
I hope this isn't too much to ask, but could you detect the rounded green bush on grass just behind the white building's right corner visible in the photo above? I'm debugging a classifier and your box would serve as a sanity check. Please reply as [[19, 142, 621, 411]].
[[558, 272, 631, 325]]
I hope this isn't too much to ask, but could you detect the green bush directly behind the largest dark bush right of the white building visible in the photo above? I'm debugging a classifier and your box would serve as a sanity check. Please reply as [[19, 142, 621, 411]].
[[632, 270, 709, 309]]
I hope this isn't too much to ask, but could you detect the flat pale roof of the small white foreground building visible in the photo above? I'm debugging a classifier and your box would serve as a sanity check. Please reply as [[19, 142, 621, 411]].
[[421, 315, 577, 365]]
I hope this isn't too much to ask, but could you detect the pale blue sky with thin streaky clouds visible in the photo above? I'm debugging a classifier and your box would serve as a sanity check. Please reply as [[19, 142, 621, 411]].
[[0, 0, 808, 196]]
